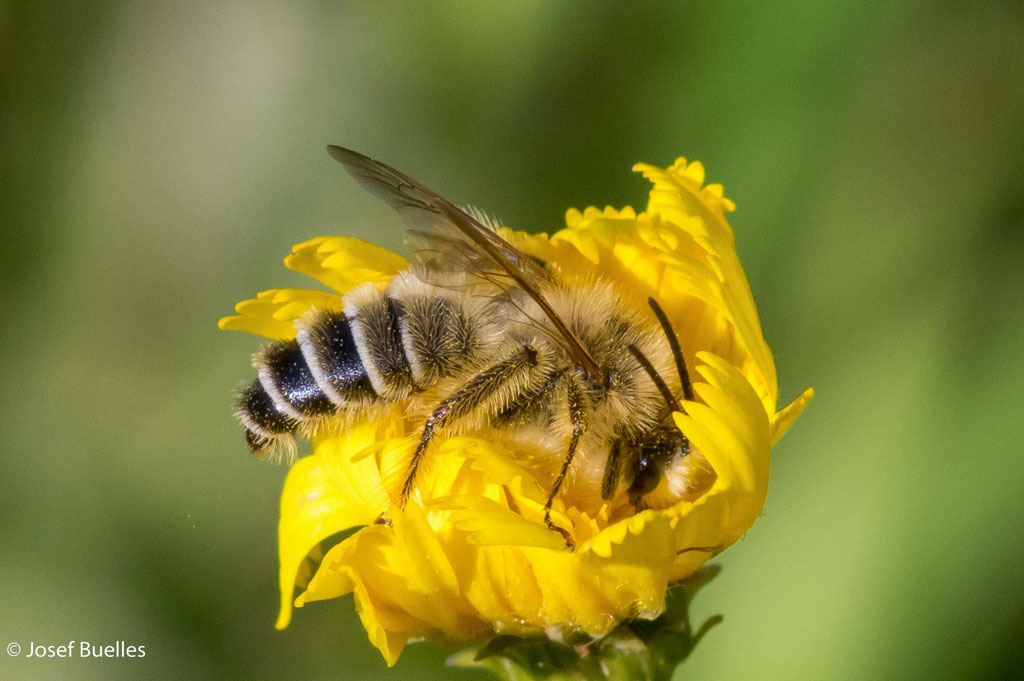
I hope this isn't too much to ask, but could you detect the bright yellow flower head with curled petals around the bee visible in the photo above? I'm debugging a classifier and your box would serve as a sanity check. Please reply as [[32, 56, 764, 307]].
[[220, 153, 813, 665]]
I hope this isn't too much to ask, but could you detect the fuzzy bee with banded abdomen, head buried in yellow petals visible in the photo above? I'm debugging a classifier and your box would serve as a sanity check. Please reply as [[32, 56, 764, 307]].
[[237, 145, 693, 542]]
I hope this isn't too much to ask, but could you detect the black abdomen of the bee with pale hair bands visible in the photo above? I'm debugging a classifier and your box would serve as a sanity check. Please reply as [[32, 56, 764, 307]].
[[236, 274, 482, 455]]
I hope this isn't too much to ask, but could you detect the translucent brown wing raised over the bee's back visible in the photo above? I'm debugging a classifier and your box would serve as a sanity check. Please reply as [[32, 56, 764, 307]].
[[327, 145, 600, 376]]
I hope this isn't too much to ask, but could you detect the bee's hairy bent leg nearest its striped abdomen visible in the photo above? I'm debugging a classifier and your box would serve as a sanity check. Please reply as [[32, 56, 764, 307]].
[[398, 345, 539, 508]]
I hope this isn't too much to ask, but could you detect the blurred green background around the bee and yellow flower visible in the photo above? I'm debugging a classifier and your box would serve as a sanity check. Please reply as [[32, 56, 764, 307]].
[[0, 1, 1024, 680]]
